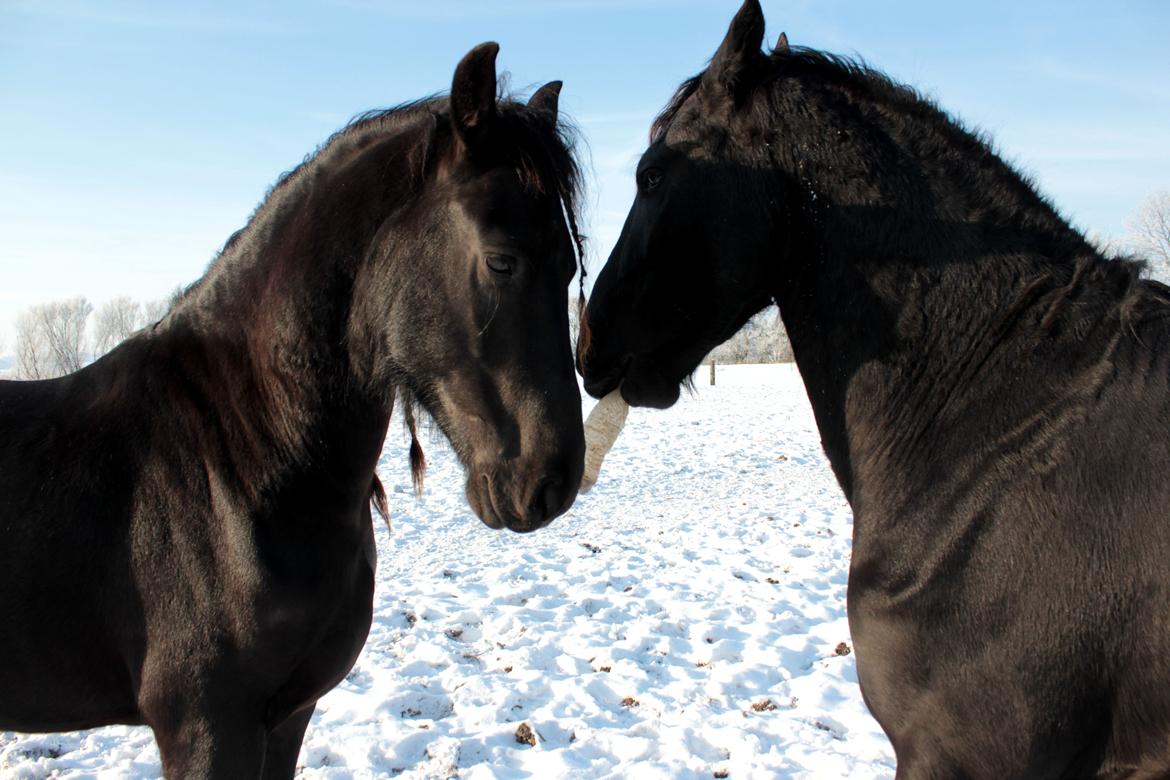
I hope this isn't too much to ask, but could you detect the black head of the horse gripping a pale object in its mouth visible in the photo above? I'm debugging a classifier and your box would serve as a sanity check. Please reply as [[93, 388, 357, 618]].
[[578, 0, 786, 408]]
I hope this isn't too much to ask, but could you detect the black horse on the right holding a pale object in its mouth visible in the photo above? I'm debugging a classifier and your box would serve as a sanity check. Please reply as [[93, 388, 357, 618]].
[[578, 0, 1170, 779]]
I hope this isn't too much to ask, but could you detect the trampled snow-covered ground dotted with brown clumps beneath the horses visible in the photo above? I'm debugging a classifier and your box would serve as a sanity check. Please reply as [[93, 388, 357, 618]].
[[0, 365, 894, 780]]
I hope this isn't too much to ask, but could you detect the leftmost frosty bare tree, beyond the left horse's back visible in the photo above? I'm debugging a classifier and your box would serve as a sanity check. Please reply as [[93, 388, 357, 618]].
[[16, 298, 94, 379]]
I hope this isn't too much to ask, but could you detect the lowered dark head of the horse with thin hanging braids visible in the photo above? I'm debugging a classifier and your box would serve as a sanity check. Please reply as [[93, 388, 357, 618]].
[[356, 43, 584, 531]]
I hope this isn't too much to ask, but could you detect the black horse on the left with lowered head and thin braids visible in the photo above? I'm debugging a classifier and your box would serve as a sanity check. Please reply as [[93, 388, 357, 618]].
[[0, 43, 584, 778]]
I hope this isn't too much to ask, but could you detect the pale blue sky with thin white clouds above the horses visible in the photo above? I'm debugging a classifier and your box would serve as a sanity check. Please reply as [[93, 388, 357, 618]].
[[0, 0, 1170, 343]]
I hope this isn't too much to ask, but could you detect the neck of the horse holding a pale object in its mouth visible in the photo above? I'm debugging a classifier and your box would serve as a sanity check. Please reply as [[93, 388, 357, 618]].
[[776, 84, 1103, 510]]
